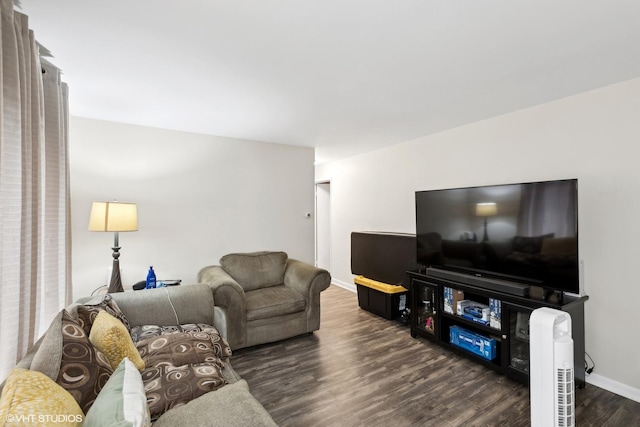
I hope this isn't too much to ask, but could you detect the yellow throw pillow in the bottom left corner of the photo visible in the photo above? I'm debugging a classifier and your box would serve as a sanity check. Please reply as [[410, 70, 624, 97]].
[[0, 368, 84, 427]]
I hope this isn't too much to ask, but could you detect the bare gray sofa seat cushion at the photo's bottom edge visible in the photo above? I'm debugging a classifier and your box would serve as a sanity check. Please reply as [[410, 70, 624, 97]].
[[153, 380, 277, 427]]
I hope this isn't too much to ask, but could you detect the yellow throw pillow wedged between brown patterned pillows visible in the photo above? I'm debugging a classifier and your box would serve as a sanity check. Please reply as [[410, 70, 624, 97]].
[[89, 311, 145, 371]]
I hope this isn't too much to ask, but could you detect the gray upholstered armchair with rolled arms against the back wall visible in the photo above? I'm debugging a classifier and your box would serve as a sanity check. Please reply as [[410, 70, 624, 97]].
[[198, 252, 331, 350]]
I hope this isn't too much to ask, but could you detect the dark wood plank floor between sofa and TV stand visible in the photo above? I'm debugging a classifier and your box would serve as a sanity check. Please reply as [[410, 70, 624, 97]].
[[231, 285, 640, 427]]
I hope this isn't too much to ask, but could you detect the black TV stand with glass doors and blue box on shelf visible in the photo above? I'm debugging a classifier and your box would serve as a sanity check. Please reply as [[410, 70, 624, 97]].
[[407, 269, 589, 388]]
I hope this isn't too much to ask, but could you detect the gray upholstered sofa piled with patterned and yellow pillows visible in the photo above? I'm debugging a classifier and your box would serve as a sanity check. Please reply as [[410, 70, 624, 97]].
[[2, 284, 276, 427]]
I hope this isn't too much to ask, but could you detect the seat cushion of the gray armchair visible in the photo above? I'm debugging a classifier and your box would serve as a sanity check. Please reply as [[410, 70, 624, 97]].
[[246, 285, 306, 320]]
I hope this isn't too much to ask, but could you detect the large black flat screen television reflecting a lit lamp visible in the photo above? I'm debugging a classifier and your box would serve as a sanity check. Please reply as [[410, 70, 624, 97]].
[[416, 179, 580, 294]]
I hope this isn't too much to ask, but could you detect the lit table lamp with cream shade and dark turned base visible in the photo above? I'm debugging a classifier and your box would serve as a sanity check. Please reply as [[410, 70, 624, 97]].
[[89, 202, 138, 293]]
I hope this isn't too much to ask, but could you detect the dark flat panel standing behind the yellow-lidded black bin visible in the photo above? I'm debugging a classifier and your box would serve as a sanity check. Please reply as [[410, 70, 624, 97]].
[[351, 232, 418, 285]]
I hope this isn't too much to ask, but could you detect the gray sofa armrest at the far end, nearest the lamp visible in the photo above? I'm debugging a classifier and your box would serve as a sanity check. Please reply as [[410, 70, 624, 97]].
[[106, 284, 215, 326]]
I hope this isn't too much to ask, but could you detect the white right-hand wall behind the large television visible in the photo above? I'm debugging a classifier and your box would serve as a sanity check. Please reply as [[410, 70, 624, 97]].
[[316, 79, 640, 401]]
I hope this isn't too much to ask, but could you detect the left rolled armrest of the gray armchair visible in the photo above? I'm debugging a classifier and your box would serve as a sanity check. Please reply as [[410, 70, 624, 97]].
[[198, 265, 247, 349]]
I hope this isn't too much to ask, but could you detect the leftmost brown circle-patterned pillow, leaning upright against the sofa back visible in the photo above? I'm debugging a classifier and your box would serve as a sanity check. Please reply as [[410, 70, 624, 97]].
[[56, 310, 113, 414]]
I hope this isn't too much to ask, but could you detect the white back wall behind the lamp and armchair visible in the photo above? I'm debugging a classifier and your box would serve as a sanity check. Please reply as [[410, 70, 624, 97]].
[[69, 117, 314, 298]]
